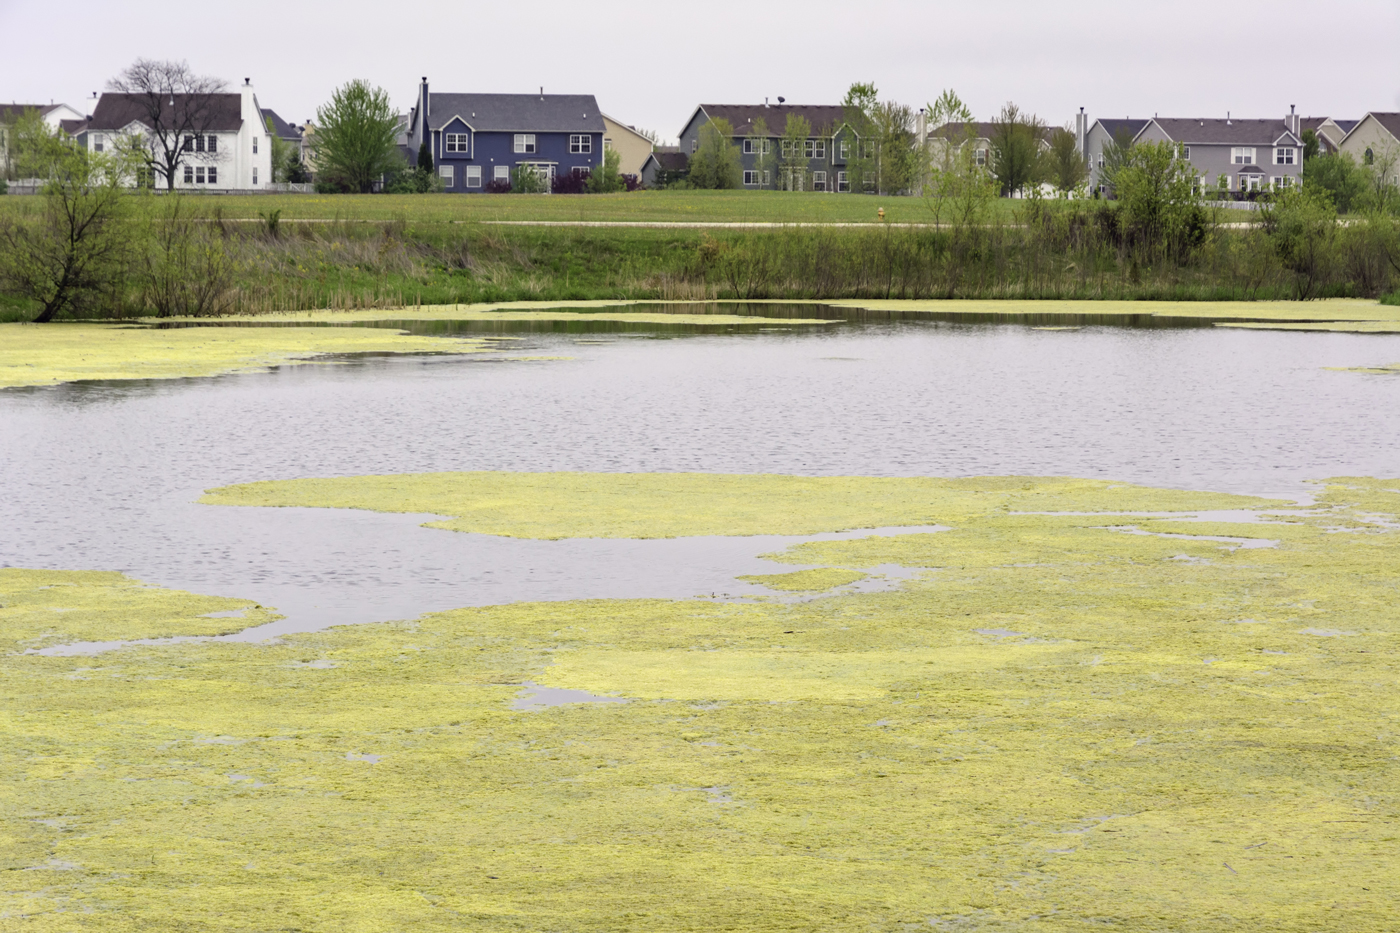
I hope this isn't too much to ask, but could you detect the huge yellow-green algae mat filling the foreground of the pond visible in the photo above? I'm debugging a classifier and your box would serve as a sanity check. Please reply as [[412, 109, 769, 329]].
[[0, 476, 1400, 933]]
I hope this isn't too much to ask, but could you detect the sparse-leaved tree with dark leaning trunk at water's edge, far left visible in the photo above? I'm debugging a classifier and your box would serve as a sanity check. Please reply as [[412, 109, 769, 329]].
[[0, 113, 137, 324]]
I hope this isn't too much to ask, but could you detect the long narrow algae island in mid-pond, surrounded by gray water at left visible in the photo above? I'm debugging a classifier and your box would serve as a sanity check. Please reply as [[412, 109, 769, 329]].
[[200, 472, 1285, 539]]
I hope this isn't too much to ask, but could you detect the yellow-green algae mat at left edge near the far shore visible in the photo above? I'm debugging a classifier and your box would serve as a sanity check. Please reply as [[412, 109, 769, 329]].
[[0, 324, 494, 388]]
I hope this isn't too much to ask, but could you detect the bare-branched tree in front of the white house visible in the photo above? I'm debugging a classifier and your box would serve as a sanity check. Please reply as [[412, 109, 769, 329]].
[[106, 59, 225, 191]]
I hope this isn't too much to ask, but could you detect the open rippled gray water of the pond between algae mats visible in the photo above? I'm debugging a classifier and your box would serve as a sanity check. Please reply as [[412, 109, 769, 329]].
[[0, 311, 1400, 630]]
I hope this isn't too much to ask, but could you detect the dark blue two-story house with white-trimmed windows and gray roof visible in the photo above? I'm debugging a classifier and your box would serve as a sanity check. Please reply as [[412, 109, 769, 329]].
[[407, 77, 605, 192]]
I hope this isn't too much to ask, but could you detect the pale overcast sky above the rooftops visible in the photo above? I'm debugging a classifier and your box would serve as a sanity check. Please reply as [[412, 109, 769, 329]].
[[0, 0, 1400, 137]]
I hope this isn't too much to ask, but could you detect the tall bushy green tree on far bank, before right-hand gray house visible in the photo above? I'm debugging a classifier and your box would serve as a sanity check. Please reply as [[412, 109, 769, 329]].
[[1116, 143, 1207, 261]]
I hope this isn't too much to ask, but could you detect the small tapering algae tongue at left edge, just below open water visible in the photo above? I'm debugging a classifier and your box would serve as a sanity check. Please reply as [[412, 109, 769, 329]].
[[0, 567, 281, 651]]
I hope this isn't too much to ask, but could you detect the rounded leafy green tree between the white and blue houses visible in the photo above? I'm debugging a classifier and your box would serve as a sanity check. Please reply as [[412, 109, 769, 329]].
[[312, 78, 403, 193]]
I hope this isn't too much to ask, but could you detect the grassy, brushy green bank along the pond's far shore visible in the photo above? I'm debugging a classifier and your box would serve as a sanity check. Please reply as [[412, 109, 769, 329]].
[[8, 192, 1400, 321]]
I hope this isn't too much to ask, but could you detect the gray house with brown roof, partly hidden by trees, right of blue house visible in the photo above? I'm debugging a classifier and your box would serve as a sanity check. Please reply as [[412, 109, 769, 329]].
[[680, 104, 858, 191]]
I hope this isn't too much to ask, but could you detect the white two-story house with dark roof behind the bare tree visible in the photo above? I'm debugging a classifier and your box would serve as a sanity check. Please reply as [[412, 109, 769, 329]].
[[78, 80, 272, 191]]
